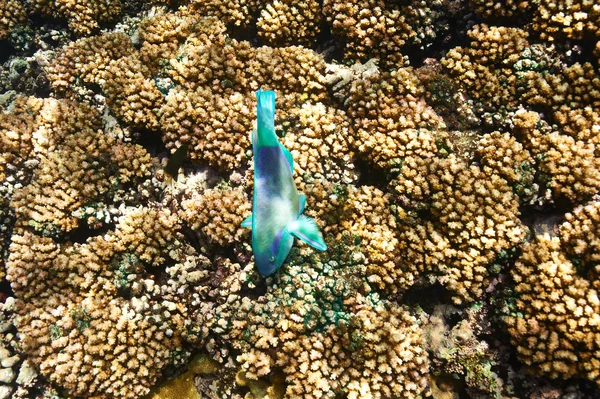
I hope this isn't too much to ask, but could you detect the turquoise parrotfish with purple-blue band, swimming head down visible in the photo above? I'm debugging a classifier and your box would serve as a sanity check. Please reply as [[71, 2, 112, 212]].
[[242, 90, 327, 276]]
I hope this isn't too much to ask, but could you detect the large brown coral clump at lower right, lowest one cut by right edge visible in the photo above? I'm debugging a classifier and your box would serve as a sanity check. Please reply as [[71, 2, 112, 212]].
[[506, 233, 600, 383]]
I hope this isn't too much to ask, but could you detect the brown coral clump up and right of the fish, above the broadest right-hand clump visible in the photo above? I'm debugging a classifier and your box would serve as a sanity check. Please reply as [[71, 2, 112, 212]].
[[336, 68, 444, 170]]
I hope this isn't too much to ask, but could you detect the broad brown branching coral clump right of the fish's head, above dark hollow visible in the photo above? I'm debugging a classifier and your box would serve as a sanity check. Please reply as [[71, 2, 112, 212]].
[[393, 155, 525, 303]]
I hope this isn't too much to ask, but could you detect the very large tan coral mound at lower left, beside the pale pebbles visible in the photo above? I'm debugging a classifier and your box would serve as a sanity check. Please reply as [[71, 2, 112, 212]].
[[7, 220, 181, 398]]
